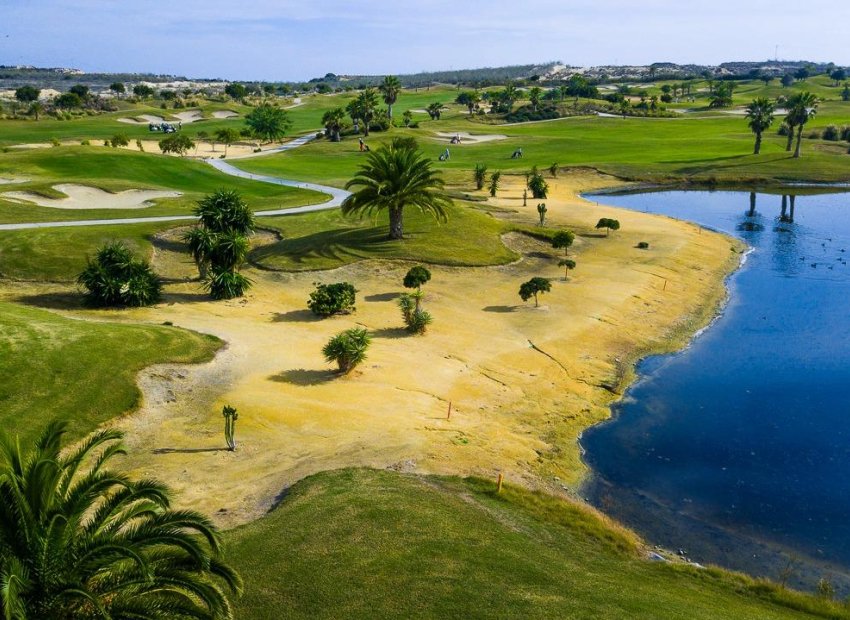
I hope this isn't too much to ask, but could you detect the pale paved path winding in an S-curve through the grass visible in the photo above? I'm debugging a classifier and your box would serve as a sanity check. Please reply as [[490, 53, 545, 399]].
[[0, 134, 350, 230]]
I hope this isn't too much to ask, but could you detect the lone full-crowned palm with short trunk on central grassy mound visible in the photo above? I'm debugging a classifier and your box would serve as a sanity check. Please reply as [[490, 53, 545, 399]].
[[342, 138, 452, 240]]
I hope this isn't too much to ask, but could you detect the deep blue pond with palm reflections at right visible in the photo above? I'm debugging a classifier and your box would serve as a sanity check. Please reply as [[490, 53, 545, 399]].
[[582, 191, 850, 582]]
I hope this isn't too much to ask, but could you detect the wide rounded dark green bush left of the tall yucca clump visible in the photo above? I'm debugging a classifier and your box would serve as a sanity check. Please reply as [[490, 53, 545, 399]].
[[77, 241, 162, 308]]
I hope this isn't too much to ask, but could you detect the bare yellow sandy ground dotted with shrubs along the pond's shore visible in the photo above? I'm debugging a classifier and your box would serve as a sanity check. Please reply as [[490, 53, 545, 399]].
[[3, 173, 740, 526]]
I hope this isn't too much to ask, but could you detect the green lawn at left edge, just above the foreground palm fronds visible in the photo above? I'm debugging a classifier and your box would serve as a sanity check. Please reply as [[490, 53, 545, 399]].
[[0, 299, 221, 442]]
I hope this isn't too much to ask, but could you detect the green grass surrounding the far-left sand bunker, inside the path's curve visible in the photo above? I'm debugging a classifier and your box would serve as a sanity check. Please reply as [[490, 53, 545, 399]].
[[0, 146, 327, 224]]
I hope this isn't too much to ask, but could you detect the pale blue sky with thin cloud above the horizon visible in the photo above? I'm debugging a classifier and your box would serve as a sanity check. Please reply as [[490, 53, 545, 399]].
[[0, 0, 850, 81]]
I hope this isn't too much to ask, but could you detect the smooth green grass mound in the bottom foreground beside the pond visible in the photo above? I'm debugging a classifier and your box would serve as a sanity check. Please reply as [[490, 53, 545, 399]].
[[226, 469, 848, 620]]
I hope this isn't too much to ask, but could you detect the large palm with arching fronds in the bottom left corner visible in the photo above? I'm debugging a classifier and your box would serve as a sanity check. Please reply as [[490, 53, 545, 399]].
[[0, 421, 242, 620]]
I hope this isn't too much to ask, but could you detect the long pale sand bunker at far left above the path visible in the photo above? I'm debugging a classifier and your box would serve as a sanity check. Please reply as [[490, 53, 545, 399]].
[[0, 183, 181, 209]]
